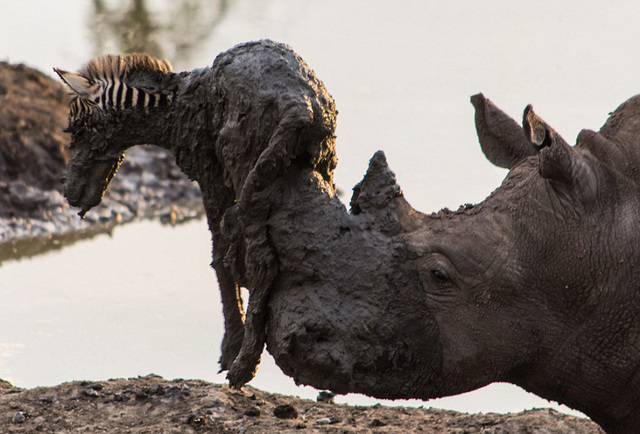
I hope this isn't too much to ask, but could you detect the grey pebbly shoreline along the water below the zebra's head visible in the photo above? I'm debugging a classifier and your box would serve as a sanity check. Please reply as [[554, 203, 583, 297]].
[[0, 147, 204, 262]]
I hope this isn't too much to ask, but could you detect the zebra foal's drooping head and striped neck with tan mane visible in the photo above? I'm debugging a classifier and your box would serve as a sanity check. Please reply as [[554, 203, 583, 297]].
[[54, 54, 176, 217]]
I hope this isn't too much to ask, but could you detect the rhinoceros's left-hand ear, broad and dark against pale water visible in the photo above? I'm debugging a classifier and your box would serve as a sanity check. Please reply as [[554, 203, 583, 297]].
[[471, 93, 536, 169]]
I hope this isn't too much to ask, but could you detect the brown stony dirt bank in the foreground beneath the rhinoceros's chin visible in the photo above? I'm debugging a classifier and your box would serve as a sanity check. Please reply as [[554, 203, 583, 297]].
[[0, 375, 603, 434]]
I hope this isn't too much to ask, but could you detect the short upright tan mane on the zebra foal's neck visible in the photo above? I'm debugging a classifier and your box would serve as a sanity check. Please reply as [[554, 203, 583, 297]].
[[78, 53, 173, 81]]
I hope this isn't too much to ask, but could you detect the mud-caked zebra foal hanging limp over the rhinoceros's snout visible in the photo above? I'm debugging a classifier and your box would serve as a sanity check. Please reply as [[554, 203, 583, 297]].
[[55, 41, 336, 386]]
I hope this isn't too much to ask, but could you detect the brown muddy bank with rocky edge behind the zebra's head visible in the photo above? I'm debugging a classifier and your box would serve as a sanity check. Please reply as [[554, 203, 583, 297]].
[[0, 63, 202, 261]]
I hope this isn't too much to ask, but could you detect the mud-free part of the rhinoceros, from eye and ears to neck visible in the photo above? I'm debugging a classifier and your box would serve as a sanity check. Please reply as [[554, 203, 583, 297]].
[[424, 95, 640, 428]]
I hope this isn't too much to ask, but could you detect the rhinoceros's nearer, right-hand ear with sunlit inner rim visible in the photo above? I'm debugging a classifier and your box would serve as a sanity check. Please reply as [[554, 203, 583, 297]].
[[522, 105, 597, 201]]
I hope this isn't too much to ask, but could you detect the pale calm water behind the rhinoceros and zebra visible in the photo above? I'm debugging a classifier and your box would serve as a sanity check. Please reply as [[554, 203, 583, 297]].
[[0, 0, 640, 418]]
